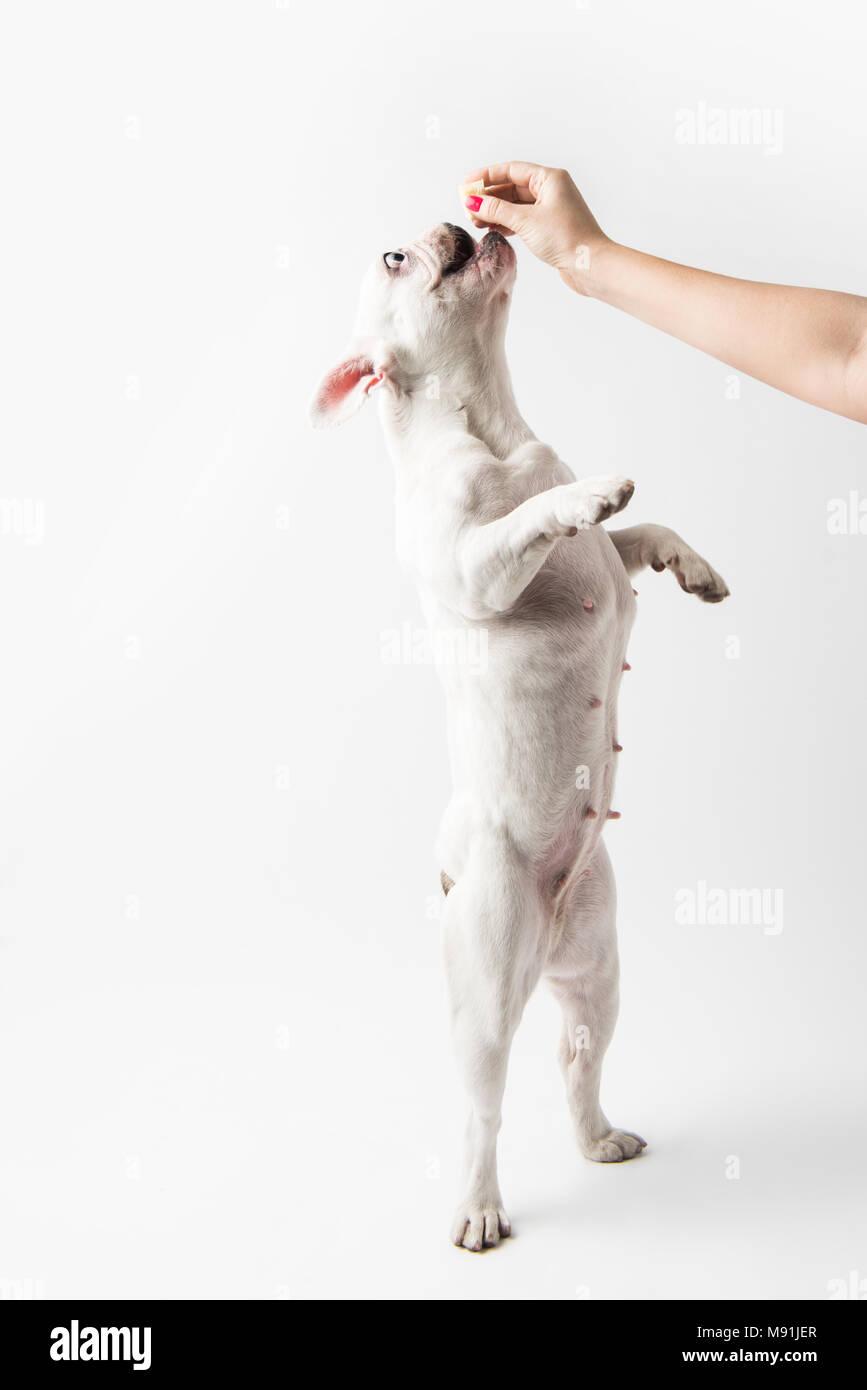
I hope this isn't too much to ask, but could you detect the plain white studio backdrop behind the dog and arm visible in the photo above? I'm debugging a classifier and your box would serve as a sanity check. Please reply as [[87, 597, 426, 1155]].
[[0, 0, 867, 1300]]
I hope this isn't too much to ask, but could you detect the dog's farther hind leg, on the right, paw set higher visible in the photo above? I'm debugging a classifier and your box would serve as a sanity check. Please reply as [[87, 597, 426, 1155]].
[[545, 844, 646, 1163]]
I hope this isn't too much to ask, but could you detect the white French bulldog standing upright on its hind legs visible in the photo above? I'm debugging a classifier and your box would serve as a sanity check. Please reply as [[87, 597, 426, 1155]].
[[311, 224, 728, 1250]]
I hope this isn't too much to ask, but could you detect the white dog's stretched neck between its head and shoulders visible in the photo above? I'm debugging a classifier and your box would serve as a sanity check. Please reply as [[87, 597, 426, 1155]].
[[378, 360, 536, 485]]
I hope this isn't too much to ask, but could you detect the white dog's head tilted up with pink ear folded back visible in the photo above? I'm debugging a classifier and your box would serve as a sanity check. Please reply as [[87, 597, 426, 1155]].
[[310, 222, 515, 425]]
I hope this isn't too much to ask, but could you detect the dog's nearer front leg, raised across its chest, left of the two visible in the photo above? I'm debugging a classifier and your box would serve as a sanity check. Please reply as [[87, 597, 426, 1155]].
[[459, 477, 635, 619]]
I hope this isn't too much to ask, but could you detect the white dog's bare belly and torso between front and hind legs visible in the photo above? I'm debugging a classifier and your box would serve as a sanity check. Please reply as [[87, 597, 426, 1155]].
[[438, 531, 635, 885]]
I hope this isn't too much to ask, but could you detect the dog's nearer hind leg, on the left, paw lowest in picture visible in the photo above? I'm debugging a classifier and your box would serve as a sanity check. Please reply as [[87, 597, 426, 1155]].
[[443, 831, 543, 1250]]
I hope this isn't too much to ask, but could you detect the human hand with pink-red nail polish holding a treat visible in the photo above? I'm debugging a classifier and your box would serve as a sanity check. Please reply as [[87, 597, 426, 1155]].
[[464, 163, 609, 295]]
